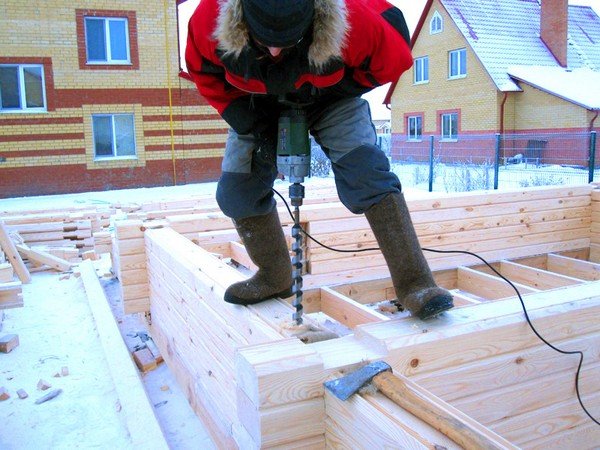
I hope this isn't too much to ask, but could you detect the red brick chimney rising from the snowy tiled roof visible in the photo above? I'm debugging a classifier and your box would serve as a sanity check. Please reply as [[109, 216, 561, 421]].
[[540, 0, 569, 67]]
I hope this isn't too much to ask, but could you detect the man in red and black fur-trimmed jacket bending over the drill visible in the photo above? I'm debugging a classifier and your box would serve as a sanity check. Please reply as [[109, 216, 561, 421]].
[[186, 0, 453, 319]]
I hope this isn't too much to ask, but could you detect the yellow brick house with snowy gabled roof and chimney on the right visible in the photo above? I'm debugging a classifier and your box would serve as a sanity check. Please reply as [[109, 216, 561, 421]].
[[384, 0, 600, 165]]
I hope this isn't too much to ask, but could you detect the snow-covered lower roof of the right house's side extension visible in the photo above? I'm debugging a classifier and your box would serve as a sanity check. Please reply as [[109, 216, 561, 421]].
[[507, 66, 600, 110]]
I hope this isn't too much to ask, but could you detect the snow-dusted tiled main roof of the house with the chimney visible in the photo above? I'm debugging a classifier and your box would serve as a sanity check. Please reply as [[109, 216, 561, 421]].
[[440, 0, 600, 91]]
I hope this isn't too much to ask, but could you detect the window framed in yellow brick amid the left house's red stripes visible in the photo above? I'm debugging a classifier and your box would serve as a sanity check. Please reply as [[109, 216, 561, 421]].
[[92, 114, 136, 159]]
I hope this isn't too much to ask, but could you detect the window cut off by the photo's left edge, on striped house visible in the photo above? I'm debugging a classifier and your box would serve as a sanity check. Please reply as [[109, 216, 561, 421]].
[[0, 64, 46, 112]]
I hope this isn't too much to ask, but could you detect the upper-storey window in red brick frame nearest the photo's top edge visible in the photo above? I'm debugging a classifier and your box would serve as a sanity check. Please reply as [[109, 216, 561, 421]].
[[85, 17, 130, 64]]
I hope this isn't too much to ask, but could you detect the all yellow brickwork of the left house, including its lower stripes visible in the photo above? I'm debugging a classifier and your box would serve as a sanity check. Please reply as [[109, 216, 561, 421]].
[[0, 0, 227, 181]]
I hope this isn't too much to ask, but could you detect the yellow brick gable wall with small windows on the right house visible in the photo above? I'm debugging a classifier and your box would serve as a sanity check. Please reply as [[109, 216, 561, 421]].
[[392, 0, 499, 135]]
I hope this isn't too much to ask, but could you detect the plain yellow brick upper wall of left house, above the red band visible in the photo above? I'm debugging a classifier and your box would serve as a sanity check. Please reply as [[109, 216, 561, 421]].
[[0, 0, 179, 89]]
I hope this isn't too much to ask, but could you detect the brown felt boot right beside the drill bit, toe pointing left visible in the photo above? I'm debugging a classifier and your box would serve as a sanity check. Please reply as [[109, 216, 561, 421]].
[[224, 210, 292, 305]]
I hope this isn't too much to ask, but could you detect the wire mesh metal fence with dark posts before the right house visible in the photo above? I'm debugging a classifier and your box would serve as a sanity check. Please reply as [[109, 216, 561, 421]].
[[389, 131, 600, 192]]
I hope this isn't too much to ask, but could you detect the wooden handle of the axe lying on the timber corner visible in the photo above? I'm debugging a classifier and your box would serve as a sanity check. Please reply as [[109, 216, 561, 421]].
[[373, 372, 518, 449]]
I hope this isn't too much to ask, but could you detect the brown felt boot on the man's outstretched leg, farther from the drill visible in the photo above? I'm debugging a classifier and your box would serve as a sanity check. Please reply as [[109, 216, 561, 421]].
[[365, 193, 454, 320]]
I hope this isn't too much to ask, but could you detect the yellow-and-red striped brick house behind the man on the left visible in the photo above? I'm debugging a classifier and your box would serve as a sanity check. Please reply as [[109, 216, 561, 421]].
[[0, 0, 227, 198]]
